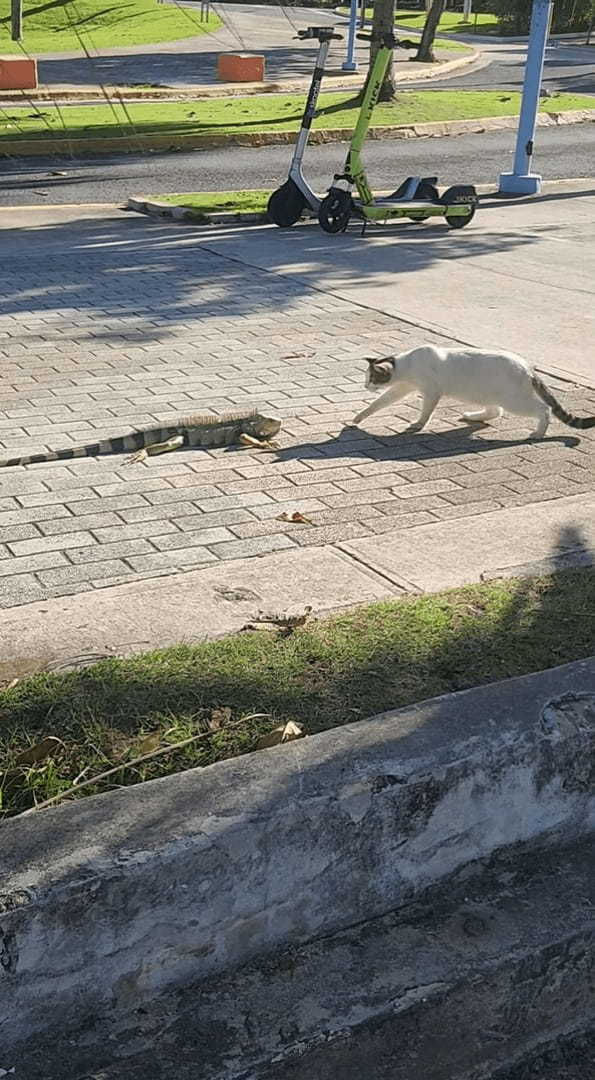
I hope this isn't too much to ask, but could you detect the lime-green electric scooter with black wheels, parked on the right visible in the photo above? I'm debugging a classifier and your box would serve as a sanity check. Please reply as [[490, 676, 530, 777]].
[[319, 33, 477, 235]]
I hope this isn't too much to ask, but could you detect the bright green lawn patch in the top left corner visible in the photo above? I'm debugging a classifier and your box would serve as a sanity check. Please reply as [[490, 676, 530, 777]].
[[0, 0, 221, 55]]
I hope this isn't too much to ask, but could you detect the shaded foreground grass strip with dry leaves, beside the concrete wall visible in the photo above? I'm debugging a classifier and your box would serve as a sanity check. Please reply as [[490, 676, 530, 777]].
[[0, 569, 595, 814]]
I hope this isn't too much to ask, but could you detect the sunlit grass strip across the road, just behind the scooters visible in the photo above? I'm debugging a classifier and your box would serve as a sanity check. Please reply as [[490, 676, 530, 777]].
[[0, 90, 595, 147]]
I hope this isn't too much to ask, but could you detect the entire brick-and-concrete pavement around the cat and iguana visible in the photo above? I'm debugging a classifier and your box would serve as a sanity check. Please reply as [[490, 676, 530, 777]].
[[0, 186, 595, 681]]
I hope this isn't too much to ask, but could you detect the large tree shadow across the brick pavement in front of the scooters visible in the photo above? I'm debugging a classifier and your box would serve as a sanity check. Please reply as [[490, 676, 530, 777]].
[[0, 209, 535, 341]]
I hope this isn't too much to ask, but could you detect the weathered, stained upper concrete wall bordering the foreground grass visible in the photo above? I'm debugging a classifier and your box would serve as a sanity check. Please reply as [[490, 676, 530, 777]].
[[0, 659, 595, 1048]]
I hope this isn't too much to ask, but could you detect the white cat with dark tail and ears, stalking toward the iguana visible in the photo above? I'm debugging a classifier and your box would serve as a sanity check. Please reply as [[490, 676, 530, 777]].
[[353, 346, 595, 438]]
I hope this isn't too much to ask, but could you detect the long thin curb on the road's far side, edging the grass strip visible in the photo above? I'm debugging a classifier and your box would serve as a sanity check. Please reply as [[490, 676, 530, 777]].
[[0, 102, 595, 157]]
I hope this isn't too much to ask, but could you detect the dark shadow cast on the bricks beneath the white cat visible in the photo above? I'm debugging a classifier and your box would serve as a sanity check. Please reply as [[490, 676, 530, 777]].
[[264, 423, 580, 461]]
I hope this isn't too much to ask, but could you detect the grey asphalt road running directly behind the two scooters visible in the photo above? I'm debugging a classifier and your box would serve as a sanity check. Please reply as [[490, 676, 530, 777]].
[[0, 123, 595, 206]]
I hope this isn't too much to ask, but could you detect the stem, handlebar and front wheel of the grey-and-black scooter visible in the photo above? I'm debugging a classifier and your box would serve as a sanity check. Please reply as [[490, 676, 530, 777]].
[[267, 26, 342, 229]]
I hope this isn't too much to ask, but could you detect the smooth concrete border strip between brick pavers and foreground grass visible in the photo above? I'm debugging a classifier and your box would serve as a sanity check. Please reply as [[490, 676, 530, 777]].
[[0, 494, 595, 686]]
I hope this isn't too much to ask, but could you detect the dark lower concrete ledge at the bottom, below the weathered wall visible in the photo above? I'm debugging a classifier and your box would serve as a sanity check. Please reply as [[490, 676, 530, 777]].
[[11, 838, 594, 1080]]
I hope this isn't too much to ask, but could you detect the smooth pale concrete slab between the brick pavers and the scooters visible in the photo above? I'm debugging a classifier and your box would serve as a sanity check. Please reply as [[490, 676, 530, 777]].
[[199, 181, 595, 386]]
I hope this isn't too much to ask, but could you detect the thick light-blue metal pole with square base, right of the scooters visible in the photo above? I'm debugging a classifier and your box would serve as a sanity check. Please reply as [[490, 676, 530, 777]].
[[500, 0, 552, 195]]
